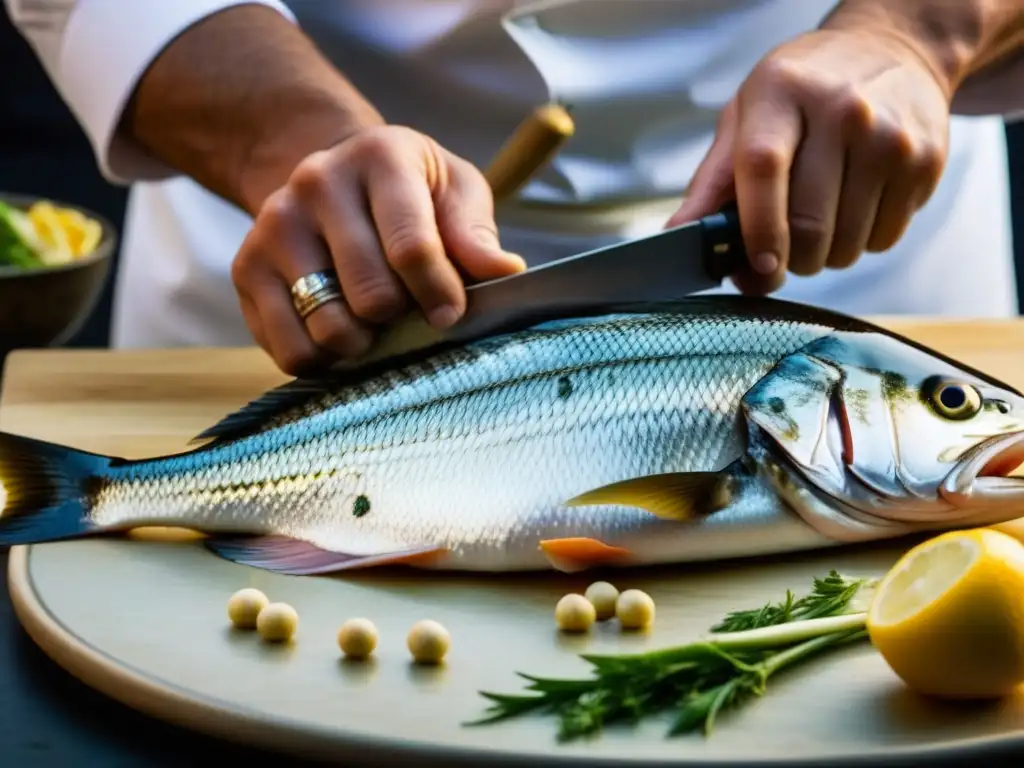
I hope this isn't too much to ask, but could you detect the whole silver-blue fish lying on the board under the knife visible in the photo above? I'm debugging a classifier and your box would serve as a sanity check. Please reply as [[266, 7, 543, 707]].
[[0, 296, 1024, 575]]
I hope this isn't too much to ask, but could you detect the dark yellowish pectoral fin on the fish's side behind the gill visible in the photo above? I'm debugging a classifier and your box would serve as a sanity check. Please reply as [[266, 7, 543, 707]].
[[565, 472, 729, 520]]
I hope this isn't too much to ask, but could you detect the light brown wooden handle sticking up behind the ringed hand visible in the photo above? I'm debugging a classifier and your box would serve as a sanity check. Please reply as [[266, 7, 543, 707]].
[[483, 104, 575, 202]]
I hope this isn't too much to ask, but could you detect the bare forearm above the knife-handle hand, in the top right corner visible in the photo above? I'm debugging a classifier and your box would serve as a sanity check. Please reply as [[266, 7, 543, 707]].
[[822, 0, 1024, 99]]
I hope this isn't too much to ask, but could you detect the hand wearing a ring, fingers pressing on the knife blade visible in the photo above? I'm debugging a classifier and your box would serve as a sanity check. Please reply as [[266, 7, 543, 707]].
[[231, 126, 524, 375]]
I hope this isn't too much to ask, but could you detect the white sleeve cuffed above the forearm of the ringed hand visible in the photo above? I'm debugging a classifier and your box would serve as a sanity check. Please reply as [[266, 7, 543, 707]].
[[4, 0, 295, 184]]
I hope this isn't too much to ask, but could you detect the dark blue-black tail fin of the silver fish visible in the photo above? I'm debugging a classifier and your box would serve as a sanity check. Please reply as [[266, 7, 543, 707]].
[[0, 432, 119, 547]]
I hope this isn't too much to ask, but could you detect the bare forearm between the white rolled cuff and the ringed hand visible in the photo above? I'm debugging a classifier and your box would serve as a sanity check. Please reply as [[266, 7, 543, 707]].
[[120, 5, 383, 213]]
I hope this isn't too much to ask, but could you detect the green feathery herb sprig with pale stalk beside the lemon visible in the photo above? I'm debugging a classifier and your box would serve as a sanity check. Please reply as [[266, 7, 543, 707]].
[[467, 570, 868, 741]]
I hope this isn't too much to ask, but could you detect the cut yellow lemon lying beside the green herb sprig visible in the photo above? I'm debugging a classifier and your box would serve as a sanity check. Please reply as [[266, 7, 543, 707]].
[[866, 528, 1024, 698]]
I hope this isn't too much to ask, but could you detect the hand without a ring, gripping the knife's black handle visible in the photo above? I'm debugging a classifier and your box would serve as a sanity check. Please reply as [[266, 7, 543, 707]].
[[668, 25, 951, 294]]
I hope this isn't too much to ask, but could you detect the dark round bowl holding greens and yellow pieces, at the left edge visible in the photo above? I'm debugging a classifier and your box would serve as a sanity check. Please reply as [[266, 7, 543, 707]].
[[0, 193, 118, 359]]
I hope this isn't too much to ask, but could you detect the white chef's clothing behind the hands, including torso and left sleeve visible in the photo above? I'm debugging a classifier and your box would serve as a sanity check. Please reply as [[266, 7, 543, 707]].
[[5, 0, 1017, 347]]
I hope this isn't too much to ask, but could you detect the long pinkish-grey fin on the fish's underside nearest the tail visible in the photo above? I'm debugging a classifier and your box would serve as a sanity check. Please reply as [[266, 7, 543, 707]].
[[204, 536, 447, 575]]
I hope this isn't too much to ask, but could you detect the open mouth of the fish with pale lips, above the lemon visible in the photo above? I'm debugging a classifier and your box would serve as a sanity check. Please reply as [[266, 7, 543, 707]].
[[939, 429, 1024, 507]]
